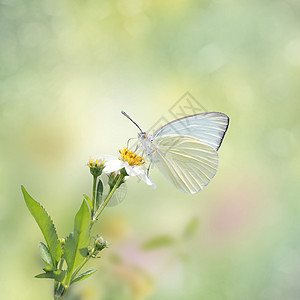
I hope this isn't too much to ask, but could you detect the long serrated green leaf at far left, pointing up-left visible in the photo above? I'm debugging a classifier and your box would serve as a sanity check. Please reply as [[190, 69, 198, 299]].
[[21, 186, 62, 267]]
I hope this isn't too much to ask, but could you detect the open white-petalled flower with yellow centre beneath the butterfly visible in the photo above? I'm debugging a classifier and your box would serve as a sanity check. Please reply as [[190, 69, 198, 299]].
[[103, 148, 155, 188]]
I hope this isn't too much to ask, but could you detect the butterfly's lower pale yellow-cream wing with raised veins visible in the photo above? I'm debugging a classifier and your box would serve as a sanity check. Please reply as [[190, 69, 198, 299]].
[[150, 135, 218, 194]]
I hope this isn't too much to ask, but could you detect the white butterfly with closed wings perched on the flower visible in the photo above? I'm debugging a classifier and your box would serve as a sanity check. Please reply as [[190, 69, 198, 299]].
[[122, 111, 229, 194]]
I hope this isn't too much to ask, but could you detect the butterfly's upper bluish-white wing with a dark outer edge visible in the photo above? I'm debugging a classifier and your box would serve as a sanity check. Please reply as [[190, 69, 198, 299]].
[[153, 112, 229, 151]]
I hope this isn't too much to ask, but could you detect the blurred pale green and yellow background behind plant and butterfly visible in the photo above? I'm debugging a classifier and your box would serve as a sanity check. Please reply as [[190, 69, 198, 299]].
[[0, 0, 300, 300]]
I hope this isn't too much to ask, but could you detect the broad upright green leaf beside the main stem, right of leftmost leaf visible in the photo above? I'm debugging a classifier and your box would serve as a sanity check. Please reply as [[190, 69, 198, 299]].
[[64, 200, 90, 280]]
